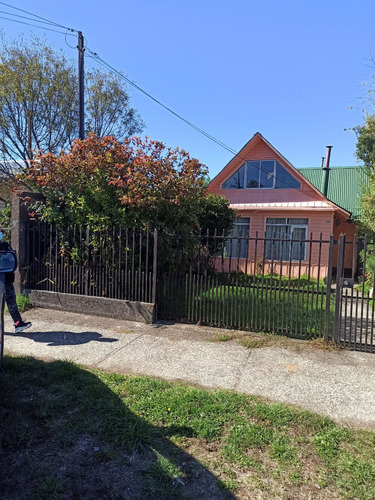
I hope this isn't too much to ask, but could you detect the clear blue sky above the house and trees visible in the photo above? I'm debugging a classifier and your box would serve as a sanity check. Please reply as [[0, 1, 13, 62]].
[[0, 0, 375, 178]]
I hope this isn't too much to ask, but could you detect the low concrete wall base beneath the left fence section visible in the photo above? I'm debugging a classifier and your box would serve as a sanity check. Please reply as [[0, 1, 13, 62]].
[[25, 290, 155, 323]]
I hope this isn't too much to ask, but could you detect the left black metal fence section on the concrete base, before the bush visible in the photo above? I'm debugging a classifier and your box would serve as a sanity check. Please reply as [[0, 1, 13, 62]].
[[26, 223, 157, 302]]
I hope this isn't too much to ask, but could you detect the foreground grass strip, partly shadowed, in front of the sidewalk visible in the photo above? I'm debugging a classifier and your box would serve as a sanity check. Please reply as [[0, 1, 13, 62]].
[[0, 356, 375, 500]]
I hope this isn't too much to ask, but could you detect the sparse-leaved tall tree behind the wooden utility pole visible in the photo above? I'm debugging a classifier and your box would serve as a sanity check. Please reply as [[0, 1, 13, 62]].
[[0, 34, 143, 176]]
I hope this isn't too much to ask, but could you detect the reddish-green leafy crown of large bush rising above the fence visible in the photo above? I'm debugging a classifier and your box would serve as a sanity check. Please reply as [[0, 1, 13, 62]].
[[26, 135, 234, 233]]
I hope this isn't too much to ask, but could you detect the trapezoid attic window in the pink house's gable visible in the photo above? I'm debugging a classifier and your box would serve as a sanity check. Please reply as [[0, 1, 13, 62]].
[[222, 160, 301, 189]]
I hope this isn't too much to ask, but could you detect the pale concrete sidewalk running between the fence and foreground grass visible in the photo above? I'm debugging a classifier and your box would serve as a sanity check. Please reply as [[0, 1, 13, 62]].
[[5, 308, 375, 430]]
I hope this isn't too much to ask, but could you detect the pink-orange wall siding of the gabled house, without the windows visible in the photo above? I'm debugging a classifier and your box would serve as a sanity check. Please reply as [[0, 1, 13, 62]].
[[209, 134, 355, 278]]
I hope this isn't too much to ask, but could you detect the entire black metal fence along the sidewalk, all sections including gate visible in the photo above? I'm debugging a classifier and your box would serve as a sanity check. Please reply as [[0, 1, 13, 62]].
[[26, 223, 375, 351]]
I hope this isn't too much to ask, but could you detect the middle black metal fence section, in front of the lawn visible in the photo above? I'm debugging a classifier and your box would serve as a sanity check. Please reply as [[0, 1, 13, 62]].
[[157, 233, 333, 338]]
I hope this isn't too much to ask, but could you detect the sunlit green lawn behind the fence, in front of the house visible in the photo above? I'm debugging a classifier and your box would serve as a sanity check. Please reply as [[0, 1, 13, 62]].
[[191, 282, 334, 338]]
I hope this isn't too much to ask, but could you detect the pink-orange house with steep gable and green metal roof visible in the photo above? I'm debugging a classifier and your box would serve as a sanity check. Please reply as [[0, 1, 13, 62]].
[[208, 133, 361, 277]]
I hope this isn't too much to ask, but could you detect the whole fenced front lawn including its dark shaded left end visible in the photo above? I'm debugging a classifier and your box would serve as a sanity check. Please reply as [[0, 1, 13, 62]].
[[158, 275, 335, 339]]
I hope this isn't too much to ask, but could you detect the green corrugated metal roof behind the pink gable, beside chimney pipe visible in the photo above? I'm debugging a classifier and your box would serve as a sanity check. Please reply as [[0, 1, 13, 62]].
[[298, 167, 368, 219]]
